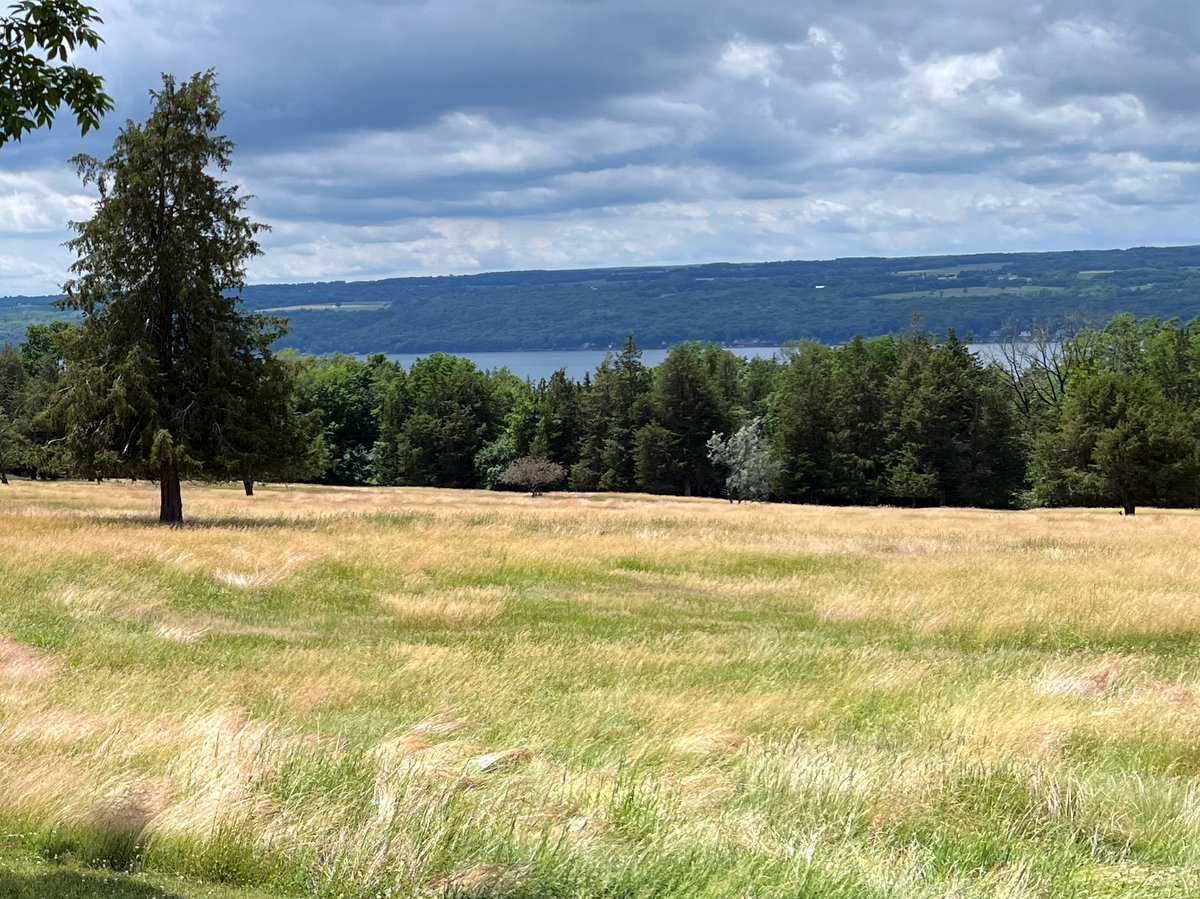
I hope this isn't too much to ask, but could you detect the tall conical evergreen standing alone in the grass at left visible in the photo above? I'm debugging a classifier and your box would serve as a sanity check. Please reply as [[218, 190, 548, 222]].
[[54, 71, 289, 525]]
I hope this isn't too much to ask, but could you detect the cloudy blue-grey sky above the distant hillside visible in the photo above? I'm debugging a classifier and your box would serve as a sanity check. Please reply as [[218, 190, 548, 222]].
[[0, 0, 1200, 295]]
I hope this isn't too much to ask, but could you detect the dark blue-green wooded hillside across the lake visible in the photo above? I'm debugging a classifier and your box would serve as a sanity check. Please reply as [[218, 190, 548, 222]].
[[11, 246, 1200, 353]]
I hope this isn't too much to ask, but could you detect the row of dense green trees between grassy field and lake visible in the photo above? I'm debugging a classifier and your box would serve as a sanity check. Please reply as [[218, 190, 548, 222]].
[[7, 314, 1200, 514]]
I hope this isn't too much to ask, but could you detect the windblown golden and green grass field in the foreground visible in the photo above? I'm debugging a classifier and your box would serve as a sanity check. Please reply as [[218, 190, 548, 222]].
[[0, 481, 1200, 899]]
